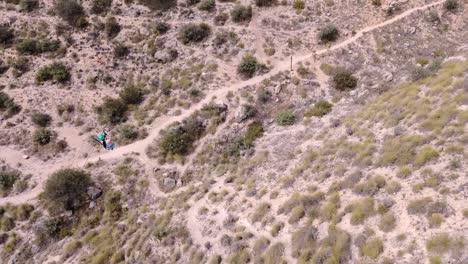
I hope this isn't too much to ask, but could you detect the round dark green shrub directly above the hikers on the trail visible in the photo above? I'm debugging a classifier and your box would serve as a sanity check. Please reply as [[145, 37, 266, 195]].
[[97, 97, 128, 125]]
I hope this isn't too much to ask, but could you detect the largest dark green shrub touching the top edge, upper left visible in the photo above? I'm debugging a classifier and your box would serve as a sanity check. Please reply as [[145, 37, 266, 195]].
[[55, 0, 87, 28]]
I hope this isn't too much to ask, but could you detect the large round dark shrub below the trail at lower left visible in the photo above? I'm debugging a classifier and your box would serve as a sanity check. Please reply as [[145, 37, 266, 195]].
[[42, 169, 91, 210]]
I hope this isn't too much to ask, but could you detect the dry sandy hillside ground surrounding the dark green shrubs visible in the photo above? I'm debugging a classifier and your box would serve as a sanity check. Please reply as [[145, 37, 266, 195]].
[[0, 1, 468, 263]]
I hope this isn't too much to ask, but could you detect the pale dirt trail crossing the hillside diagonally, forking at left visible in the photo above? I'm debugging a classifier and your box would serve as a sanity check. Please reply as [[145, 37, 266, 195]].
[[0, 0, 445, 205]]
